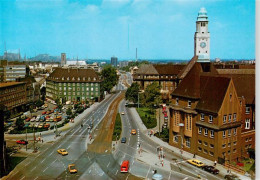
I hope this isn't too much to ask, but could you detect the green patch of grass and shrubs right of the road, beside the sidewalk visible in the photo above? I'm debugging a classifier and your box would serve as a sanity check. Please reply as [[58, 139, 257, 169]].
[[136, 107, 157, 129]]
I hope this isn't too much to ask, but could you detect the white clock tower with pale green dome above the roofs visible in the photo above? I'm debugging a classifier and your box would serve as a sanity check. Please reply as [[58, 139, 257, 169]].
[[194, 8, 210, 62]]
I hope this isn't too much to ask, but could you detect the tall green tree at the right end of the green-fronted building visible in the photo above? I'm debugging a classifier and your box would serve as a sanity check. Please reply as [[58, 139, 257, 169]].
[[101, 65, 118, 93]]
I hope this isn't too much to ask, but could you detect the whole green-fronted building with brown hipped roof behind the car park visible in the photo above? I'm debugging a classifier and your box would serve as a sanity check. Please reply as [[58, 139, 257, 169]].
[[46, 68, 103, 102]]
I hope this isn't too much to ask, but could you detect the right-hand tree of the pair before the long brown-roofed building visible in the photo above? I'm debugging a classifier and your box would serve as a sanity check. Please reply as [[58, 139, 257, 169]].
[[142, 82, 162, 108]]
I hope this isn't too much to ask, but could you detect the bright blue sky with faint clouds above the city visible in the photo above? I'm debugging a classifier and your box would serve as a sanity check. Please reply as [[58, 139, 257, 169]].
[[0, 0, 255, 60]]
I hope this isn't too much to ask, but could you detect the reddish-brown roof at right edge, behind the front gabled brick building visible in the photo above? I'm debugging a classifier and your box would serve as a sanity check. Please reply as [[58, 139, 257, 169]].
[[218, 74, 255, 104]]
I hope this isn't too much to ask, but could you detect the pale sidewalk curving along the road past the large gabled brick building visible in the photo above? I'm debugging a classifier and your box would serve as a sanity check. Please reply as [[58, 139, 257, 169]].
[[130, 108, 251, 180]]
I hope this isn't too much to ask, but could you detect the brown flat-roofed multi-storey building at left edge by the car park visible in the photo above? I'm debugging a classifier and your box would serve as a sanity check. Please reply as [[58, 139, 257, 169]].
[[0, 82, 27, 114]]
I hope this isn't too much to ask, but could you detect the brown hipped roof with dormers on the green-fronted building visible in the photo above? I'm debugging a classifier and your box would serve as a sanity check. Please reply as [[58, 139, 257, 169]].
[[47, 68, 101, 82]]
